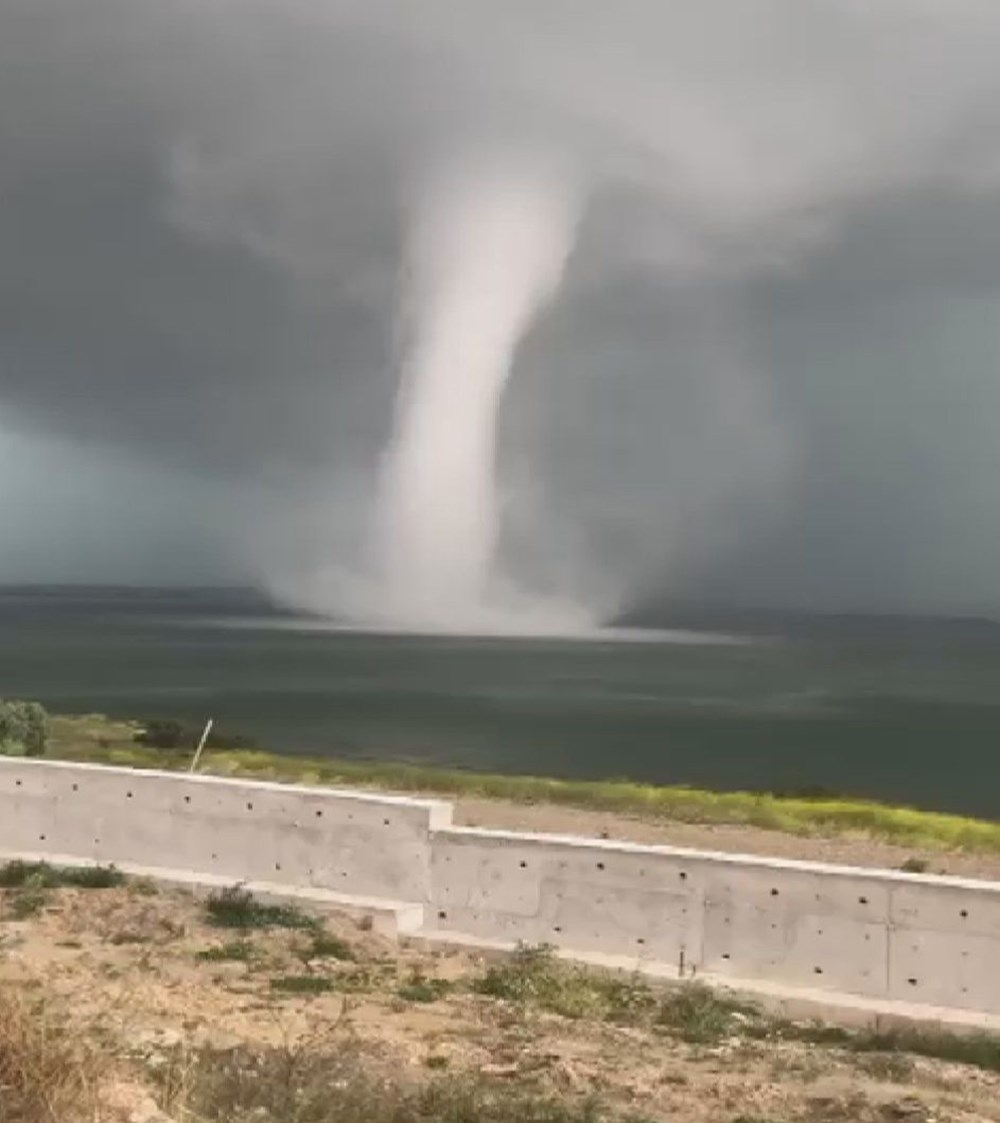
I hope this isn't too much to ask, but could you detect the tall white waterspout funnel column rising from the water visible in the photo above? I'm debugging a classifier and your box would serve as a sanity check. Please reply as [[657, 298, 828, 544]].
[[378, 158, 576, 630]]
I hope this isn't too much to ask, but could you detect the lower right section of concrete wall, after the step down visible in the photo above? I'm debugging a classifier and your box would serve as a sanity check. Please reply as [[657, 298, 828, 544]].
[[425, 829, 1000, 1013]]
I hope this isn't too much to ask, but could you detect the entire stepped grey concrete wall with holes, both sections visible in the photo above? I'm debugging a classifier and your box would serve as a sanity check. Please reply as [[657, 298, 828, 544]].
[[0, 758, 1000, 1015]]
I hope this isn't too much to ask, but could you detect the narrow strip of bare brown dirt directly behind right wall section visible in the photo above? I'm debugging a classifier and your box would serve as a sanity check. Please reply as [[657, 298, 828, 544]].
[[455, 798, 1000, 880]]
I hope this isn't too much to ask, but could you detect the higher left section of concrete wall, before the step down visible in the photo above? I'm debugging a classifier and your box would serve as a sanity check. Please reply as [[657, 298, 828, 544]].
[[0, 758, 451, 901]]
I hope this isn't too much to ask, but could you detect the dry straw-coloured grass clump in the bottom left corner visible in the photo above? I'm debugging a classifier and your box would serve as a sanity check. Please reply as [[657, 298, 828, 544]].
[[0, 986, 109, 1123]]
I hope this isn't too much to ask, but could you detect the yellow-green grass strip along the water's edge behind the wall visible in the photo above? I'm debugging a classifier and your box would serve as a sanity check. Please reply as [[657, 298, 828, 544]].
[[48, 715, 1000, 853]]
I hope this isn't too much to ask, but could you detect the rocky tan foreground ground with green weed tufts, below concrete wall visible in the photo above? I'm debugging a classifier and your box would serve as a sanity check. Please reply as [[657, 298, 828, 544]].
[[0, 871, 1000, 1123]]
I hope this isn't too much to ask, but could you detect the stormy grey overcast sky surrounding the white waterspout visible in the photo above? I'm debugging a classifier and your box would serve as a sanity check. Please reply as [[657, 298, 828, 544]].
[[0, 0, 1000, 612]]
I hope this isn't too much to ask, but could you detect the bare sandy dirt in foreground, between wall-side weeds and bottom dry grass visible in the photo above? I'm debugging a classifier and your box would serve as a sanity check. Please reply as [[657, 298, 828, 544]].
[[0, 884, 1000, 1123]]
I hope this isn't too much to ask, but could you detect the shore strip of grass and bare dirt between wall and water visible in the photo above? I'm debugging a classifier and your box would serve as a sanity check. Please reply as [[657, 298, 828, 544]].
[[46, 714, 1000, 880]]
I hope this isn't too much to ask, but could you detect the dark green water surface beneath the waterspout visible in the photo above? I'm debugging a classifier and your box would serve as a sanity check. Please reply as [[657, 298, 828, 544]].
[[0, 588, 1000, 818]]
